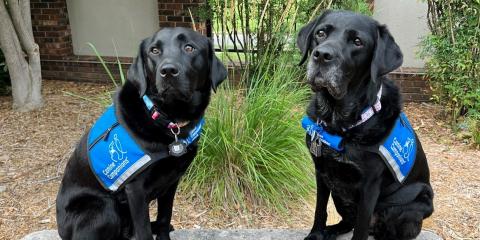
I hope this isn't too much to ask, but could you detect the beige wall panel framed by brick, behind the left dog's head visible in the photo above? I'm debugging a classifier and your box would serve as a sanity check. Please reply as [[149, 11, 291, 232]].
[[67, 0, 159, 57]]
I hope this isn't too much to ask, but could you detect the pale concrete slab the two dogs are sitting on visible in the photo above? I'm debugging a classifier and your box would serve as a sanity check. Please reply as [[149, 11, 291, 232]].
[[22, 229, 442, 240]]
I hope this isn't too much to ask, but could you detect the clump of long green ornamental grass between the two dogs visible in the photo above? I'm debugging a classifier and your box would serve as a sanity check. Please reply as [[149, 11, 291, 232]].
[[181, 53, 314, 211]]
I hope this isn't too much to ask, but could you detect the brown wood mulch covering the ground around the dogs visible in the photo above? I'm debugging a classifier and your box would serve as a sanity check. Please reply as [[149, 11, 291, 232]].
[[0, 81, 480, 239]]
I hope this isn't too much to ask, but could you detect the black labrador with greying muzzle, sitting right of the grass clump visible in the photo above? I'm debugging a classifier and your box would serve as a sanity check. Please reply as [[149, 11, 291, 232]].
[[297, 10, 433, 240]]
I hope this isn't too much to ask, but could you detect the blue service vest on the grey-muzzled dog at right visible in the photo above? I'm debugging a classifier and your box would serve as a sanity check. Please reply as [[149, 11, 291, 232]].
[[302, 112, 417, 183]]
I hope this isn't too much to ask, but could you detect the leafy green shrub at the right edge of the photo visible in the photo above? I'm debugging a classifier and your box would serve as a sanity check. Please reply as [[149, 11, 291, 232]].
[[420, 0, 480, 144]]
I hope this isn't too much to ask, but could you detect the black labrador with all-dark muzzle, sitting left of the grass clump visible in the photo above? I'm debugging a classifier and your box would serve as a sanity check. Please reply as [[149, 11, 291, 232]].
[[56, 28, 227, 240]]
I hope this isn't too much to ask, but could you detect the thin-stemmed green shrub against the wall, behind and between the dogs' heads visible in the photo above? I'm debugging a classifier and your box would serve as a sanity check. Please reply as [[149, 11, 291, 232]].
[[206, 0, 370, 73]]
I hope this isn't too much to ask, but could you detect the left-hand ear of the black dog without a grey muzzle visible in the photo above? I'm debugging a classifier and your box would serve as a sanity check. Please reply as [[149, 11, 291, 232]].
[[127, 39, 147, 97]]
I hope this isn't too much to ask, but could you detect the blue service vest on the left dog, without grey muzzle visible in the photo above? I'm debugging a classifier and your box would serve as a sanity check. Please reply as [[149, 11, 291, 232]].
[[87, 105, 204, 191]]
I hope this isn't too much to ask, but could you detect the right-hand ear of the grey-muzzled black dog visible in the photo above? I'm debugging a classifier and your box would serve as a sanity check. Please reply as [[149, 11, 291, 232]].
[[370, 25, 403, 81]]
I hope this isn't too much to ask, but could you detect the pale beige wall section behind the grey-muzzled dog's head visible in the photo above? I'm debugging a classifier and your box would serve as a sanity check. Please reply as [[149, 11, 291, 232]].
[[373, 0, 429, 68]]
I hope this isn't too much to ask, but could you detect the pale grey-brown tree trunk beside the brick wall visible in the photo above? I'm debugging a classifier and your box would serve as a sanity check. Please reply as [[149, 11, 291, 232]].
[[0, 0, 43, 111]]
